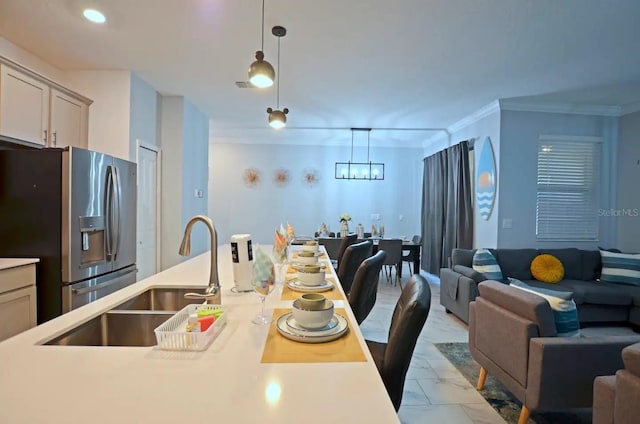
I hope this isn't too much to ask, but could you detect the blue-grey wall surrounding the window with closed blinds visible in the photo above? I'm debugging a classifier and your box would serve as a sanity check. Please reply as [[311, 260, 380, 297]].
[[498, 110, 618, 249]]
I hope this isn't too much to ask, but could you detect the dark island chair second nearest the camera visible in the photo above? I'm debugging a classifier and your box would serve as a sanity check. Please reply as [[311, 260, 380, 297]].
[[347, 252, 387, 325]]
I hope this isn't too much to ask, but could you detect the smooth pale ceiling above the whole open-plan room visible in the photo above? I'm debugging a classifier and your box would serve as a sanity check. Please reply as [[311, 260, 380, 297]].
[[0, 0, 640, 145]]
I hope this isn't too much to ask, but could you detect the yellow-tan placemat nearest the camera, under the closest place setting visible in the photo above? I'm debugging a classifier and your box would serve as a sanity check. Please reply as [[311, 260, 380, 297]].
[[260, 308, 367, 364]]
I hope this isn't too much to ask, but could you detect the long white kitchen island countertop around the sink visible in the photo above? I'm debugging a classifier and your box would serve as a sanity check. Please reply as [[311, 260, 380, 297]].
[[0, 245, 399, 424]]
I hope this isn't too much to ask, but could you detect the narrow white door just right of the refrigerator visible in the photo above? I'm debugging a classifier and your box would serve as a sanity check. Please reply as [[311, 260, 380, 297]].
[[136, 143, 160, 280]]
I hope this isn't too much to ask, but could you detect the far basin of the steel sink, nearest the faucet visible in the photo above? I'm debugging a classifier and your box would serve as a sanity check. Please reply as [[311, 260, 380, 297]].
[[112, 287, 203, 312]]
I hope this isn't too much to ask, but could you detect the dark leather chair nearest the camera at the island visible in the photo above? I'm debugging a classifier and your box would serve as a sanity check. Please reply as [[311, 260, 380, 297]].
[[366, 274, 431, 411]]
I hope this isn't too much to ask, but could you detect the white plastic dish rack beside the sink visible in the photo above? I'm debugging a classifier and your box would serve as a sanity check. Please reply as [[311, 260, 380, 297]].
[[154, 305, 227, 351]]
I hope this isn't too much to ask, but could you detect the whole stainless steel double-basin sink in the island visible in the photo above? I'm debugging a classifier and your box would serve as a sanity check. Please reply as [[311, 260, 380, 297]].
[[42, 287, 203, 346]]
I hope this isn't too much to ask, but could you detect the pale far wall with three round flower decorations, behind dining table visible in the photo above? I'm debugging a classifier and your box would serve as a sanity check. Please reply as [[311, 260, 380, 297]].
[[209, 139, 423, 244]]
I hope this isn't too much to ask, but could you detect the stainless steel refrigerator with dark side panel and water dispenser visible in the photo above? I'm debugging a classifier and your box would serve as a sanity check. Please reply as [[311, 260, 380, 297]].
[[0, 147, 137, 323]]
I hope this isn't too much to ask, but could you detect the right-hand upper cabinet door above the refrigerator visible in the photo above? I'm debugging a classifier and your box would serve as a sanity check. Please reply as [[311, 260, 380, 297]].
[[49, 88, 88, 148]]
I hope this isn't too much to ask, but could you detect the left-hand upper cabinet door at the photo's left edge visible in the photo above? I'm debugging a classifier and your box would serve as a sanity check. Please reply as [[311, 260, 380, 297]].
[[0, 64, 50, 146]]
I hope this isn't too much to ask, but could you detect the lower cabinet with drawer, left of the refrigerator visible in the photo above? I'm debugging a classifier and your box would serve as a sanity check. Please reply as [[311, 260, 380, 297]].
[[0, 264, 37, 341]]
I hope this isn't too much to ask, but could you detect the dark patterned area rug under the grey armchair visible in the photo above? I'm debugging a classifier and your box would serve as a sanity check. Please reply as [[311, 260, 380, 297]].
[[435, 343, 592, 424]]
